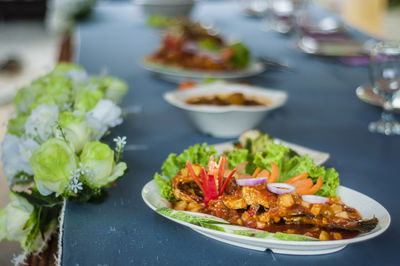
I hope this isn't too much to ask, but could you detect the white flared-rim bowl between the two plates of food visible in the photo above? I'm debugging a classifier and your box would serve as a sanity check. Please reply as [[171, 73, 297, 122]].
[[164, 82, 287, 138]]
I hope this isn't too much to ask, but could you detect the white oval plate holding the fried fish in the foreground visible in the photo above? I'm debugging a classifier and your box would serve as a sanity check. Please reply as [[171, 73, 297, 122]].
[[142, 180, 390, 255]]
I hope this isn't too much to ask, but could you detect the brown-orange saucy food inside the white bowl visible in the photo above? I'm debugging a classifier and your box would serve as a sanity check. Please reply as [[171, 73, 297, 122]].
[[186, 92, 271, 106]]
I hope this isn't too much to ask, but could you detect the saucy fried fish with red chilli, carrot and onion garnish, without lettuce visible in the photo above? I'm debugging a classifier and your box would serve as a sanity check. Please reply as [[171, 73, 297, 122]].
[[172, 156, 378, 240]]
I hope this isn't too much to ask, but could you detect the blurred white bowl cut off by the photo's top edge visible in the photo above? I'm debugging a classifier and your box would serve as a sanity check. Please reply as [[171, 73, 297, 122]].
[[135, 0, 196, 17]]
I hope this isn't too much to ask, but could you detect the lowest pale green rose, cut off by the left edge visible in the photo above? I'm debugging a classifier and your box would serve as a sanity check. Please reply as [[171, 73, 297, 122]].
[[0, 192, 34, 247]]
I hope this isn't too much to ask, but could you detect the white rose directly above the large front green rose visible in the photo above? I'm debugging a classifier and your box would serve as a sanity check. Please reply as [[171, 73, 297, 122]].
[[25, 104, 58, 143]]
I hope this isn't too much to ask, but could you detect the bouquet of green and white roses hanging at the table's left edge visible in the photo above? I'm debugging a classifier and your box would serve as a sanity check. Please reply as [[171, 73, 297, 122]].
[[0, 64, 128, 260]]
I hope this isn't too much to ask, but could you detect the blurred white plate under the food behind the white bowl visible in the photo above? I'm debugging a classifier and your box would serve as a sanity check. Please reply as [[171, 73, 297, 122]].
[[140, 60, 265, 83]]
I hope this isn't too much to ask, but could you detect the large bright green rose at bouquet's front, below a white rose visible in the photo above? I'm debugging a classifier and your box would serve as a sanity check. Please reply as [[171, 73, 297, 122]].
[[30, 138, 77, 195]]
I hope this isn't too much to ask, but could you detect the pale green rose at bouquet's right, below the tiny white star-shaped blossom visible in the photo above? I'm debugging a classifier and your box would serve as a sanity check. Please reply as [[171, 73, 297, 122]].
[[80, 141, 127, 188]]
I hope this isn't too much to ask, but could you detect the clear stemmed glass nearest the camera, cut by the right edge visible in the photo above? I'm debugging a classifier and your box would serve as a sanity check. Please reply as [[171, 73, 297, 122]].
[[368, 41, 400, 135]]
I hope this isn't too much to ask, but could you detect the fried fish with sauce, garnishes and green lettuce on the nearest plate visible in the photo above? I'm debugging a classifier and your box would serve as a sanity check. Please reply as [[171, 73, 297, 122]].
[[154, 131, 378, 240]]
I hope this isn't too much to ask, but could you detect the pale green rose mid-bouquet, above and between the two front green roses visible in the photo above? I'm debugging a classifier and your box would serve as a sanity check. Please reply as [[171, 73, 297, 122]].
[[56, 112, 94, 153]]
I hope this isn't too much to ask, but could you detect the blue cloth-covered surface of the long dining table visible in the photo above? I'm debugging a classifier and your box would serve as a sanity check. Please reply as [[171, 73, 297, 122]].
[[62, 2, 400, 265]]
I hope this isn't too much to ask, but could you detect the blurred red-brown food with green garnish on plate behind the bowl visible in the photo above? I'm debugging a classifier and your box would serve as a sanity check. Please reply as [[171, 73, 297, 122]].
[[146, 20, 250, 71]]
